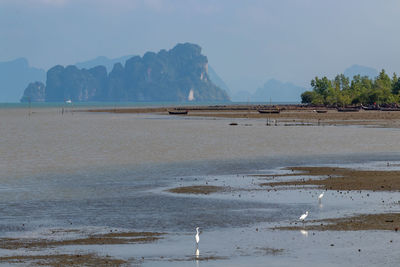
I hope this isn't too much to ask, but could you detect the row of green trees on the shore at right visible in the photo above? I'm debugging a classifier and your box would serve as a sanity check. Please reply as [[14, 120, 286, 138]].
[[301, 69, 400, 107]]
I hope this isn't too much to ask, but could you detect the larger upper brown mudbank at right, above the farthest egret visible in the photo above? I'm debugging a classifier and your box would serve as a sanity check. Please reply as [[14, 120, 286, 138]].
[[260, 167, 400, 191]]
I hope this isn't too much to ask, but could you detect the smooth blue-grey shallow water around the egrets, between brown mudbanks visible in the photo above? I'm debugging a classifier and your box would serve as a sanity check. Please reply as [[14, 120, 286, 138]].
[[0, 162, 400, 266]]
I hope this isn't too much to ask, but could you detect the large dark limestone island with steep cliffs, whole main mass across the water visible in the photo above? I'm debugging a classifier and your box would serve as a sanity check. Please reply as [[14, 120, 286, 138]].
[[21, 43, 229, 102]]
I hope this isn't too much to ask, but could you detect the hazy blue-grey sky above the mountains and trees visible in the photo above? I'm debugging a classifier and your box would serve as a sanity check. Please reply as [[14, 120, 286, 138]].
[[0, 0, 400, 91]]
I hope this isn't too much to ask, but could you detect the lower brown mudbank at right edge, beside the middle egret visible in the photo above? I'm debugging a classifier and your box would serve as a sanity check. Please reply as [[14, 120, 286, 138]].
[[273, 213, 400, 232]]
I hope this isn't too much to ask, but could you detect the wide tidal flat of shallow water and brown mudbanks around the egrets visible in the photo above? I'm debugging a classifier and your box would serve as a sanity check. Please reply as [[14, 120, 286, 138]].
[[0, 108, 400, 266]]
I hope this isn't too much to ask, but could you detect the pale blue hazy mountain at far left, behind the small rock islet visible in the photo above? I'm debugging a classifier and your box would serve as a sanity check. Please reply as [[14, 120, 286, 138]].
[[0, 58, 46, 103]]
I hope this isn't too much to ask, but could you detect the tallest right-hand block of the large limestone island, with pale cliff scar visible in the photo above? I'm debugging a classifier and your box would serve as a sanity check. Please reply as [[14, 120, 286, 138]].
[[109, 43, 228, 101]]
